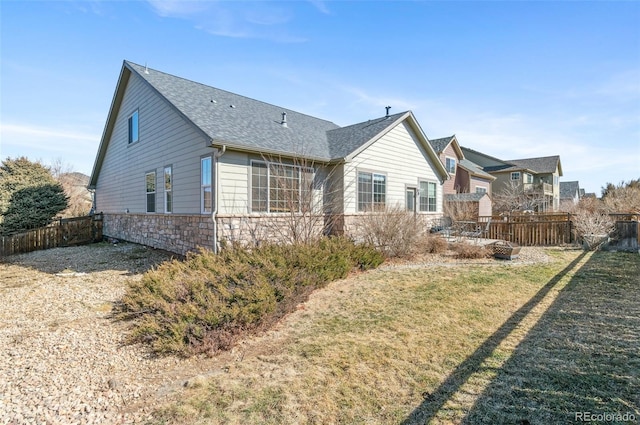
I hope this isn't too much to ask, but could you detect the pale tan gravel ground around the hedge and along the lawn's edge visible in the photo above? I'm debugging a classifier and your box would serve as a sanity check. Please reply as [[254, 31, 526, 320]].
[[0, 243, 548, 425]]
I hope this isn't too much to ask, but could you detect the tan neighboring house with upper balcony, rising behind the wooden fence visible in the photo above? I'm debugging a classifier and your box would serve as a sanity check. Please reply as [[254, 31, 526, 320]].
[[461, 147, 562, 212]]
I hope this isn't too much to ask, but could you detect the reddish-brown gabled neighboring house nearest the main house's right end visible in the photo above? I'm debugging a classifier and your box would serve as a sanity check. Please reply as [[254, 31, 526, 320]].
[[429, 135, 496, 218]]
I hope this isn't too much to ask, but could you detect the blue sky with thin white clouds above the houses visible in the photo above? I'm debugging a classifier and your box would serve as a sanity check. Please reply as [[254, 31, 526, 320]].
[[0, 0, 640, 194]]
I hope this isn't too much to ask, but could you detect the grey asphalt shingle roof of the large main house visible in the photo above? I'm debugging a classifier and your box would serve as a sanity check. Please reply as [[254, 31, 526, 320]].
[[125, 61, 406, 161]]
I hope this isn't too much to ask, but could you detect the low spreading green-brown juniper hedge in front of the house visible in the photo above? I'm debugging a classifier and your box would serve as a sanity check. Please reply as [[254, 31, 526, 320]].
[[116, 238, 383, 356]]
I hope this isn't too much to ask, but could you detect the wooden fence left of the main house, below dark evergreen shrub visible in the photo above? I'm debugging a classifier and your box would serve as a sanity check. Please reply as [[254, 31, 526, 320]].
[[0, 214, 102, 256]]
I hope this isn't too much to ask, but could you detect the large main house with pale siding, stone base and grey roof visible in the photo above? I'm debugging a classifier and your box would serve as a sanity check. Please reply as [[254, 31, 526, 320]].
[[89, 61, 448, 253]]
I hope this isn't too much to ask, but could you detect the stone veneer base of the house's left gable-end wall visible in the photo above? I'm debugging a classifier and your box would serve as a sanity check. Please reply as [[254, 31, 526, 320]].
[[102, 213, 215, 255]]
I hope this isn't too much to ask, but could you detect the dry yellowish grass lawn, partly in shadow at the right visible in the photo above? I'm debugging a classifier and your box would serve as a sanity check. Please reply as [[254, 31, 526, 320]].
[[148, 249, 640, 424]]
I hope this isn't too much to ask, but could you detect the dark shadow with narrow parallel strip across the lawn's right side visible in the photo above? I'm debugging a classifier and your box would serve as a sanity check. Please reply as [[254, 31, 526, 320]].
[[404, 252, 640, 424]]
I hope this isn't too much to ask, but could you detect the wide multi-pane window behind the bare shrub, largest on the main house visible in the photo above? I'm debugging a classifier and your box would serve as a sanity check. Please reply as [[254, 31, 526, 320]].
[[251, 161, 313, 213]]
